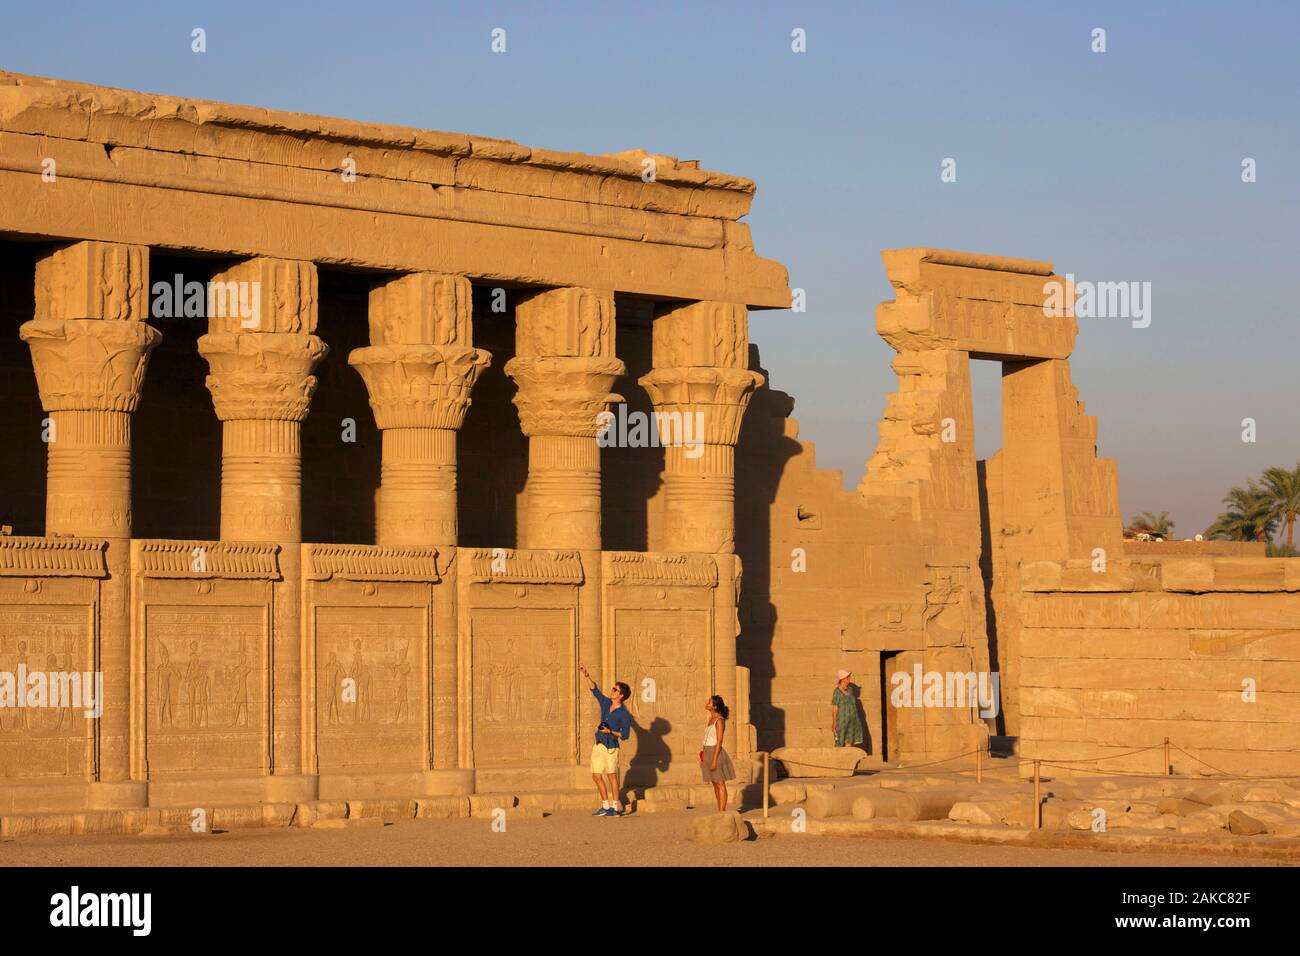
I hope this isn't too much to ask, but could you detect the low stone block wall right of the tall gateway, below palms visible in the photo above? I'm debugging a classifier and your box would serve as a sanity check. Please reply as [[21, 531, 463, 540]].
[[1019, 558, 1300, 775]]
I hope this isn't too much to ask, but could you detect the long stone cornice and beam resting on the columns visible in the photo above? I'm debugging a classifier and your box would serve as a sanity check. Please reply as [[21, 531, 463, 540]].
[[0, 73, 790, 308]]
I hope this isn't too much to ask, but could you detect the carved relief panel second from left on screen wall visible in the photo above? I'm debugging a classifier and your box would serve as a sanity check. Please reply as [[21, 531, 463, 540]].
[[144, 605, 267, 774]]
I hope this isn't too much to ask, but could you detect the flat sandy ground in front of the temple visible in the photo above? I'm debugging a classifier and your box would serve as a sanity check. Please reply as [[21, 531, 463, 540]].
[[0, 810, 1278, 866]]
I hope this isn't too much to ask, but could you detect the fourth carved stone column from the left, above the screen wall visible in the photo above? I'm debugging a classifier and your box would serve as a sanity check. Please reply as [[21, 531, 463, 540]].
[[506, 289, 624, 551]]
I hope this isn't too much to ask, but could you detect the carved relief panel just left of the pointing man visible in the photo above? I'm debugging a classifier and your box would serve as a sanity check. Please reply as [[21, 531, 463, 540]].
[[471, 607, 577, 767]]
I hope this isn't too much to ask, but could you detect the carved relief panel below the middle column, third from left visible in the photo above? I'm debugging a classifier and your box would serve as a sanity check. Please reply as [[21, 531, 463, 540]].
[[315, 607, 429, 771]]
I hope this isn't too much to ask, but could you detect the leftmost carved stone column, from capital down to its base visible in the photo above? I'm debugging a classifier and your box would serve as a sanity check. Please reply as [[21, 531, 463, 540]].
[[18, 242, 163, 790]]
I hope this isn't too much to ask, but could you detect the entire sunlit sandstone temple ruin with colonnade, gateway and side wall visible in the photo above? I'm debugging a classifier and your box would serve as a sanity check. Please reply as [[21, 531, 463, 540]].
[[0, 73, 1300, 813]]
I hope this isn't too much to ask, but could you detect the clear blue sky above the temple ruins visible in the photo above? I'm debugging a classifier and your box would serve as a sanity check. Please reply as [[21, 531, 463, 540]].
[[0, 0, 1300, 536]]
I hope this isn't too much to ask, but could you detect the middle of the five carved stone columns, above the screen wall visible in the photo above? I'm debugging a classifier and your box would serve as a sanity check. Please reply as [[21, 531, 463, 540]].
[[347, 273, 491, 545]]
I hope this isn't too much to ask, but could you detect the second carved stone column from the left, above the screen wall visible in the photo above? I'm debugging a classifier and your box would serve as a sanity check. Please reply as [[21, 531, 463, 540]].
[[199, 259, 329, 542]]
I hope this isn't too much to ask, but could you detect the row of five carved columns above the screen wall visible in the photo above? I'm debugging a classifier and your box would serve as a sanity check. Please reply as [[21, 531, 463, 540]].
[[20, 242, 762, 553]]
